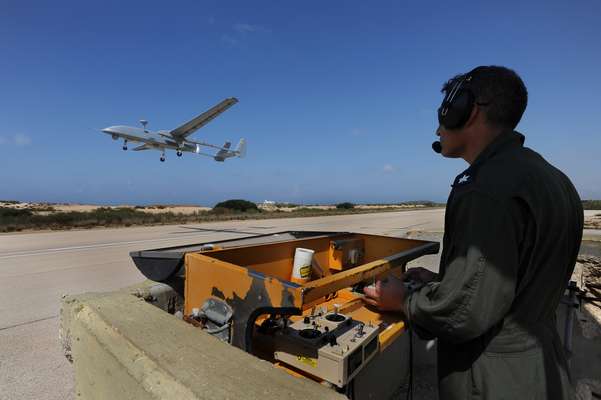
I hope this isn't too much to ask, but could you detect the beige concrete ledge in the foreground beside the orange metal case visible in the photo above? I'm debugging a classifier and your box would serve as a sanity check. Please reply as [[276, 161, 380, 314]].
[[61, 284, 346, 400]]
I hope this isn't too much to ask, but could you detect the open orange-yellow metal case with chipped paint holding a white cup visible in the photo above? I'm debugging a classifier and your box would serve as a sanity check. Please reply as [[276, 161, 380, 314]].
[[184, 233, 439, 349]]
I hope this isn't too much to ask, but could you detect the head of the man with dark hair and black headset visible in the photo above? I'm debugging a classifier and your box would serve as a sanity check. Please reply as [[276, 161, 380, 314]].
[[437, 66, 528, 163]]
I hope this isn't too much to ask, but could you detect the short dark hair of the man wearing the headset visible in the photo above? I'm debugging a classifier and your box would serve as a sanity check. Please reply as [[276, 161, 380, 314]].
[[442, 65, 528, 129]]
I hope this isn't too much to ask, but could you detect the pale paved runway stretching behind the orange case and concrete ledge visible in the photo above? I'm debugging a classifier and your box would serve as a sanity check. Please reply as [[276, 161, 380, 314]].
[[0, 209, 444, 400]]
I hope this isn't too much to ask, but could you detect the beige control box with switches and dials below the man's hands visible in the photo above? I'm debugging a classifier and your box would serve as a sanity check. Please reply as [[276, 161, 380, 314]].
[[273, 310, 379, 387]]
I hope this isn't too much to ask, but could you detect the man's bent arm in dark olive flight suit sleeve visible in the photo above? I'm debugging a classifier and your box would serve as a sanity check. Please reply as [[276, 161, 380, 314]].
[[404, 190, 520, 343]]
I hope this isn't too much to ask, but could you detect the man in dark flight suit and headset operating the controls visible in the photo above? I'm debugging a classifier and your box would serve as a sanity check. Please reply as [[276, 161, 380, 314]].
[[365, 66, 583, 400]]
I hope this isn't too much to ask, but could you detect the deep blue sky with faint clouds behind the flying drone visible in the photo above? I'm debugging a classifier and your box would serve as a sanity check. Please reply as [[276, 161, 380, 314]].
[[0, 0, 601, 206]]
